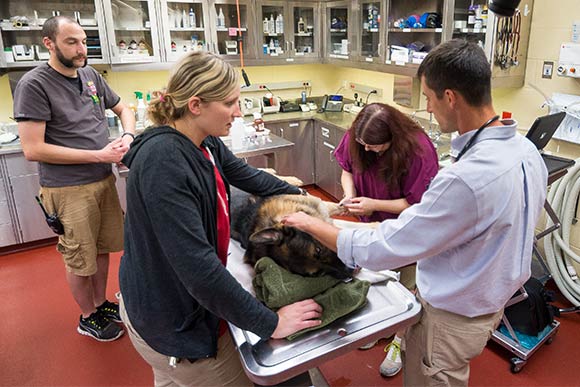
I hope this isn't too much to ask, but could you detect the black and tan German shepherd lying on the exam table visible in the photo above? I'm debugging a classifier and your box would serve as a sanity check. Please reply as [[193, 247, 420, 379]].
[[230, 187, 352, 279]]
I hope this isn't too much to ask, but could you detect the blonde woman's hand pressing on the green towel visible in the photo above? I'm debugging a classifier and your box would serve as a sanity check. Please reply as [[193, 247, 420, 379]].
[[272, 299, 322, 339]]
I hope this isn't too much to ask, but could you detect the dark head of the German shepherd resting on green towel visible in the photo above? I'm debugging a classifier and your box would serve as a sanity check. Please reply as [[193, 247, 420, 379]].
[[248, 223, 352, 279]]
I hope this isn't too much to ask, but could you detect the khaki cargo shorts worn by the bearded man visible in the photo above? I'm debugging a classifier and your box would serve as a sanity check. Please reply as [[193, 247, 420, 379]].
[[40, 174, 123, 276]]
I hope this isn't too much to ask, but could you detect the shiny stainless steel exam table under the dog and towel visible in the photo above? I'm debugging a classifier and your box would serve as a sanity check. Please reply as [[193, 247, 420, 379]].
[[228, 241, 421, 385]]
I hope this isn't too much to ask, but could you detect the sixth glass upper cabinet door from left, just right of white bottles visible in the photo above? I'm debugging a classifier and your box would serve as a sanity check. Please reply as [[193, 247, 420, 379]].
[[288, 2, 322, 60]]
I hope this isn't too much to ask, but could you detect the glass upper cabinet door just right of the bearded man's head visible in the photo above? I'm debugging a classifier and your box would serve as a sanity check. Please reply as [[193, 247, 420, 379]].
[[102, 0, 161, 64]]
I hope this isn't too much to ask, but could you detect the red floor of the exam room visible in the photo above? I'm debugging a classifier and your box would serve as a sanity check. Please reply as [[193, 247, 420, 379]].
[[0, 186, 580, 387]]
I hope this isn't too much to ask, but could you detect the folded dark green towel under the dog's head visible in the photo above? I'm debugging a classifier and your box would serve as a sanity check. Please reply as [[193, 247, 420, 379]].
[[252, 257, 371, 340]]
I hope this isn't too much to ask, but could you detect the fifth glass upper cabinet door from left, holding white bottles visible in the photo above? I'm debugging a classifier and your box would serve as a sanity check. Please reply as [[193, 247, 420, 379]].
[[256, 0, 291, 58]]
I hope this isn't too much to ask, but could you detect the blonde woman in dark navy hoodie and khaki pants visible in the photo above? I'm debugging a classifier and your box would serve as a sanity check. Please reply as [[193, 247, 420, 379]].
[[119, 52, 321, 386]]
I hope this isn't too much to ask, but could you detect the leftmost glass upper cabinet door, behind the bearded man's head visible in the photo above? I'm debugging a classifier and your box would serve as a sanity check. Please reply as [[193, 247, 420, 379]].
[[0, 0, 108, 68]]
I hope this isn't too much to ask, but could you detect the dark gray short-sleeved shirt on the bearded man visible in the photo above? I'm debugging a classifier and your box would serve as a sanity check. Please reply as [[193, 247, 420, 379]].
[[14, 64, 120, 187]]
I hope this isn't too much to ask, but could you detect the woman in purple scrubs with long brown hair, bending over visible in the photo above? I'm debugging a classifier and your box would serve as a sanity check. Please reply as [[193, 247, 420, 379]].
[[334, 103, 439, 376]]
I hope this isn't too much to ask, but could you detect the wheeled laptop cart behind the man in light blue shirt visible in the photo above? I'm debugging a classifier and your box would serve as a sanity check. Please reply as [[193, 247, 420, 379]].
[[491, 160, 574, 373]]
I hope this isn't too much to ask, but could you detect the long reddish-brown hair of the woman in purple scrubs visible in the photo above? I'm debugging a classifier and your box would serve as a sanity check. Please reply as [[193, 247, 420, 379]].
[[349, 103, 423, 190]]
